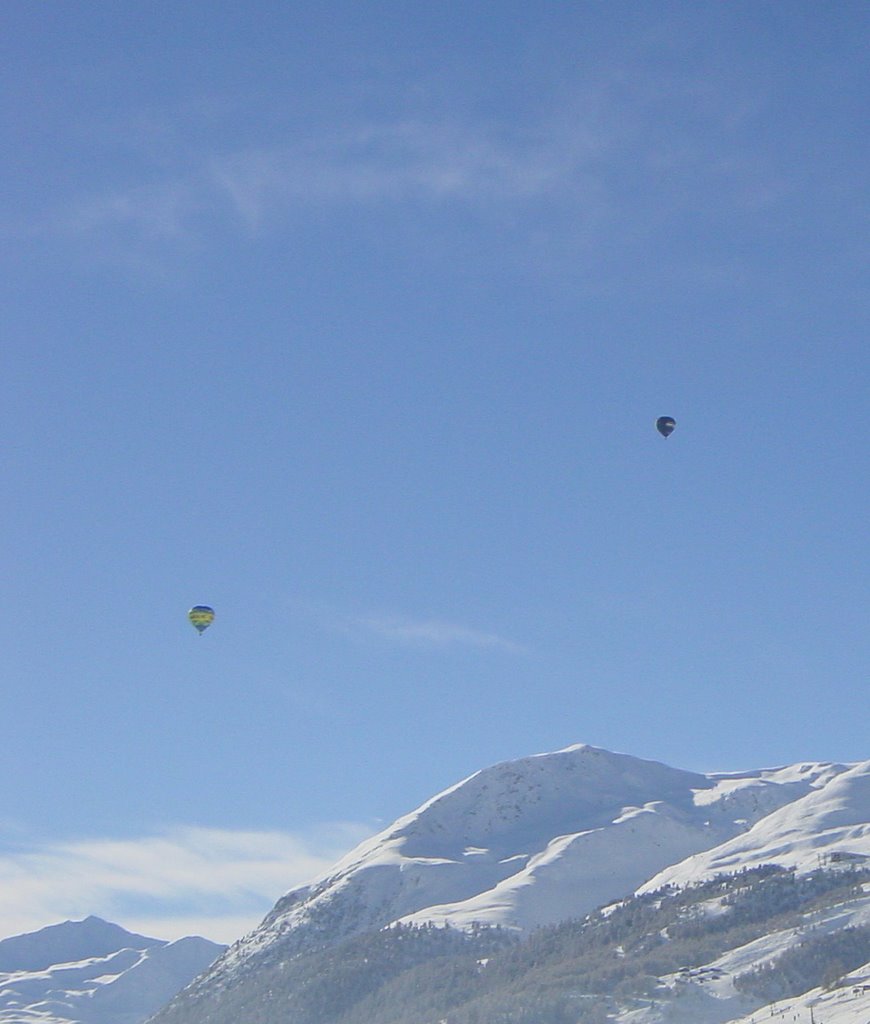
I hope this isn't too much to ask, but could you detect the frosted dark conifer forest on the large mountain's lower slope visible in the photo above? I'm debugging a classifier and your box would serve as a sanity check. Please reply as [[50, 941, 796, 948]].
[[145, 865, 870, 1024]]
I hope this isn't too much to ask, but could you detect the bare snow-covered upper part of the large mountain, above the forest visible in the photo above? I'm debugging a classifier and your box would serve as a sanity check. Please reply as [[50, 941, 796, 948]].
[[149, 745, 870, 1022]]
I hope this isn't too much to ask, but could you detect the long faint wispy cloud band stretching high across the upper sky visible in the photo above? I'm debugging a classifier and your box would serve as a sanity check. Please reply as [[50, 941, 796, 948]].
[[27, 61, 787, 283]]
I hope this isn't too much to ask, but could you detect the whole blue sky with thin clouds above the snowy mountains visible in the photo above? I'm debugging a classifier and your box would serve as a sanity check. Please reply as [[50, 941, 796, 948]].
[[0, 0, 870, 939]]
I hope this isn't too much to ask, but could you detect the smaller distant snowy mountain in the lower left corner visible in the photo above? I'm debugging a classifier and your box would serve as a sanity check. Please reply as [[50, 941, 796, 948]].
[[0, 918, 225, 1024]]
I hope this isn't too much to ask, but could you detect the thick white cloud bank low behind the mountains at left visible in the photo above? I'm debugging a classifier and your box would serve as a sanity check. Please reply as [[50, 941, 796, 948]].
[[0, 822, 373, 942]]
